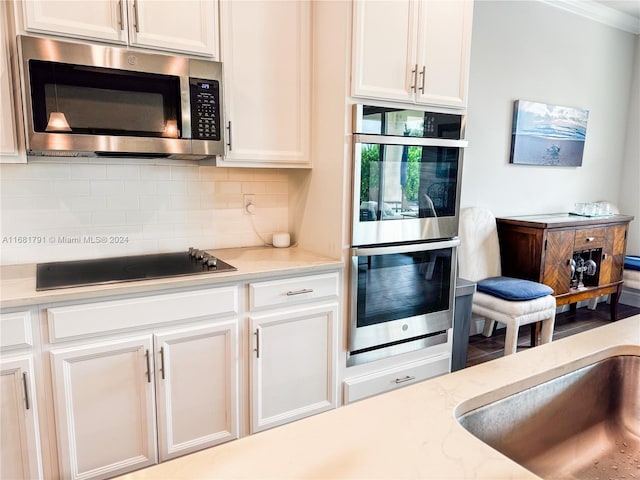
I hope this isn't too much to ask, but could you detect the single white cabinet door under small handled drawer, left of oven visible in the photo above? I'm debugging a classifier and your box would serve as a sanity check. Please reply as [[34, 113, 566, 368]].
[[251, 303, 338, 432]]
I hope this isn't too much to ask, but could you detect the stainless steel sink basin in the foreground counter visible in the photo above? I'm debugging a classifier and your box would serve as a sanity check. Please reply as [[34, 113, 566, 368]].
[[458, 355, 640, 480]]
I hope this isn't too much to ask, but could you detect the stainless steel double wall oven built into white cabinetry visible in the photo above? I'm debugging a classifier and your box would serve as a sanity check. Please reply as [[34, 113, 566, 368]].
[[348, 105, 467, 365]]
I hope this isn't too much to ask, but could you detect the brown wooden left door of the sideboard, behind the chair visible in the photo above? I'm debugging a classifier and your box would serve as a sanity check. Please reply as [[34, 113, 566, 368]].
[[542, 230, 575, 295]]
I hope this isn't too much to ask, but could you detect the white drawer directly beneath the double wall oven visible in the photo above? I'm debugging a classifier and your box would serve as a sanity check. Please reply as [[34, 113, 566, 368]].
[[344, 353, 451, 403]]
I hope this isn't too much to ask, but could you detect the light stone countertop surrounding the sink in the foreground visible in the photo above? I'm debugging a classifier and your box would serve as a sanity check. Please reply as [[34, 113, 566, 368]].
[[120, 315, 640, 480]]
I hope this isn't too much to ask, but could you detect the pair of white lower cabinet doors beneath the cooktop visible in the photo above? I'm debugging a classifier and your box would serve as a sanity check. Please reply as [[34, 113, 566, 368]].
[[51, 321, 237, 479]]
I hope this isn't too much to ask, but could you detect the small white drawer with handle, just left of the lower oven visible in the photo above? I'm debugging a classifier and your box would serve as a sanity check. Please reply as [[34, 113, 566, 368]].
[[249, 272, 339, 310]]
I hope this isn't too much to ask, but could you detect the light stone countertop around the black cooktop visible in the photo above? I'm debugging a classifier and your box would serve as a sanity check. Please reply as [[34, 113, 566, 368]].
[[0, 247, 344, 308]]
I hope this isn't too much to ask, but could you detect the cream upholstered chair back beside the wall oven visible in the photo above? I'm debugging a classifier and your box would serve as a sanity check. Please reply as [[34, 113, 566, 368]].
[[458, 207, 502, 282]]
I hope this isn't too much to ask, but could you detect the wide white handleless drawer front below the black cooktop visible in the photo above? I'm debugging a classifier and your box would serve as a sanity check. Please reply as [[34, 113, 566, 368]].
[[47, 286, 238, 343]]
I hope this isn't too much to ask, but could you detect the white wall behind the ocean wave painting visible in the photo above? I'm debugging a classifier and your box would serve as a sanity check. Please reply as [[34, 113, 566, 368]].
[[461, 0, 640, 223]]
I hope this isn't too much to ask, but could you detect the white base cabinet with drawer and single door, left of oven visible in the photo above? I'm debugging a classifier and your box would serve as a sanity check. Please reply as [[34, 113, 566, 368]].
[[249, 273, 339, 432]]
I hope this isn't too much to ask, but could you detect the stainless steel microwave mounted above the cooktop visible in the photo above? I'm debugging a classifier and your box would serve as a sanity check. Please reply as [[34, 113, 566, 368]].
[[18, 36, 224, 159]]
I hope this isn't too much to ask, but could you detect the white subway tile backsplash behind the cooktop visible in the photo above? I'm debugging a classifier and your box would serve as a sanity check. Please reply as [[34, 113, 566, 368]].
[[0, 163, 289, 265]]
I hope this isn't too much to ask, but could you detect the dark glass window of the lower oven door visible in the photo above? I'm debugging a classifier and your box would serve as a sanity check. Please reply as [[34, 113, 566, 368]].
[[356, 248, 452, 328]]
